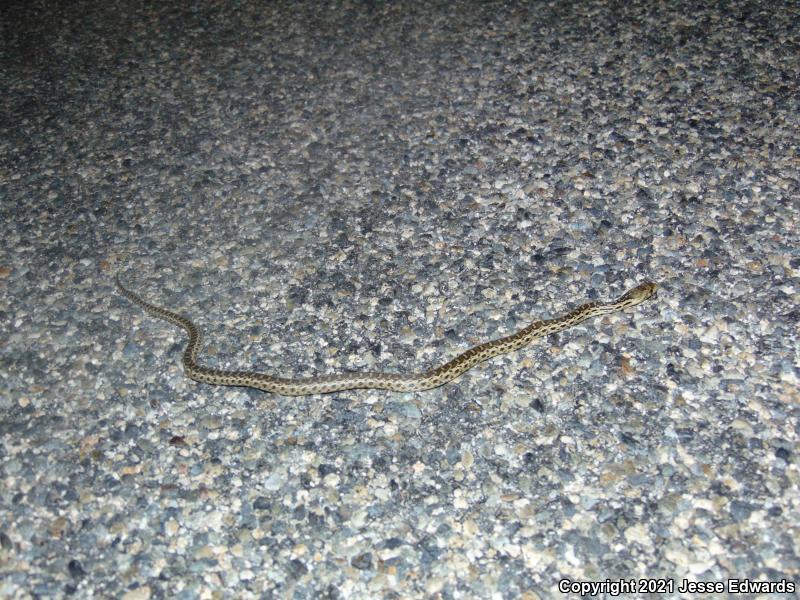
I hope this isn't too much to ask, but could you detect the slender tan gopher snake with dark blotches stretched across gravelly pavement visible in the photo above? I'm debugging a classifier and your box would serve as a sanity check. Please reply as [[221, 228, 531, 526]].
[[115, 275, 658, 396]]
